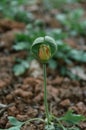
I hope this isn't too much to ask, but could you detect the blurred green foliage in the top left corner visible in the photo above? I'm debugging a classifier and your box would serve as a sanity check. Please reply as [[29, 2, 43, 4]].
[[0, 0, 34, 23]]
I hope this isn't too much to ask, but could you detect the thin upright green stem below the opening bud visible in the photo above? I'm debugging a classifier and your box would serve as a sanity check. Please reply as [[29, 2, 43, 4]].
[[43, 64, 49, 125]]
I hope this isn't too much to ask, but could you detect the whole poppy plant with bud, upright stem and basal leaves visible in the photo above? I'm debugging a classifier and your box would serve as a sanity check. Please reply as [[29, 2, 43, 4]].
[[0, 36, 86, 130]]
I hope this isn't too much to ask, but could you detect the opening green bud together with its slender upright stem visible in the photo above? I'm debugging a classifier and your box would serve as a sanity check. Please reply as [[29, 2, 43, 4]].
[[31, 36, 57, 126]]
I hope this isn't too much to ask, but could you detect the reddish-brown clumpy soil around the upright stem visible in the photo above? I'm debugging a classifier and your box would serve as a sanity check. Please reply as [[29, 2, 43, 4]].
[[0, 2, 86, 130]]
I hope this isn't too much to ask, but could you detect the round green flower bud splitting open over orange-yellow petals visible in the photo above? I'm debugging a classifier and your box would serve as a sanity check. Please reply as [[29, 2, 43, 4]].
[[31, 36, 57, 63]]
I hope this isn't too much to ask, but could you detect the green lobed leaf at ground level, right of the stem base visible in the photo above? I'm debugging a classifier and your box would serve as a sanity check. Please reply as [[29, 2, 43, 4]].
[[60, 110, 86, 124]]
